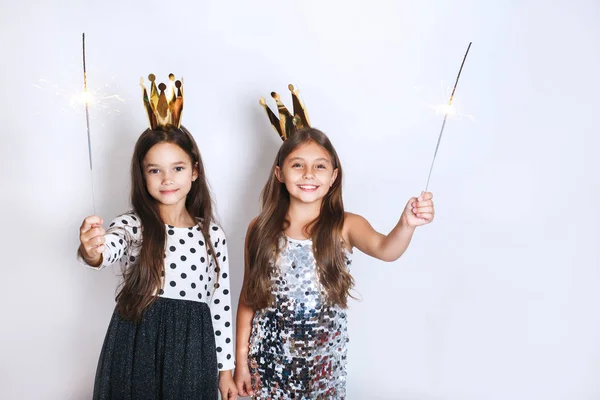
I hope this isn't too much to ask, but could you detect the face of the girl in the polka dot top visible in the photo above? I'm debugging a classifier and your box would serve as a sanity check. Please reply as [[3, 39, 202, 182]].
[[143, 143, 198, 207]]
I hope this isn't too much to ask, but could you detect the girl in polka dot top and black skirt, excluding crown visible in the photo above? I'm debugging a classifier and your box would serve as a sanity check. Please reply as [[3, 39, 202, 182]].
[[78, 126, 237, 400]]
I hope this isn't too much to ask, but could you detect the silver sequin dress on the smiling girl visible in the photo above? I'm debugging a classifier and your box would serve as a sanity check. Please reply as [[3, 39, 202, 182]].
[[248, 238, 351, 399]]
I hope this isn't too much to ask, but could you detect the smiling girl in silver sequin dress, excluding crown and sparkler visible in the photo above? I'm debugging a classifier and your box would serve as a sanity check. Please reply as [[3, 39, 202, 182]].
[[235, 127, 434, 399]]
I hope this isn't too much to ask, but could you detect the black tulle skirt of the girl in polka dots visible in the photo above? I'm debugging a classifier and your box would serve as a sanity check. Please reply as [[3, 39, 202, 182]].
[[94, 297, 218, 400]]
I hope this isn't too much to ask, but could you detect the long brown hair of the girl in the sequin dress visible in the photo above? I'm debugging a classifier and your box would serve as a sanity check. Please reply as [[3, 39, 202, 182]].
[[244, 128, 354, 309]]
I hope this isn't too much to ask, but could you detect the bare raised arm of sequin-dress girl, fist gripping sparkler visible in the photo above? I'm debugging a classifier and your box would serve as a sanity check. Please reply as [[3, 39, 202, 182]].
[[344, 192, 434, 261]]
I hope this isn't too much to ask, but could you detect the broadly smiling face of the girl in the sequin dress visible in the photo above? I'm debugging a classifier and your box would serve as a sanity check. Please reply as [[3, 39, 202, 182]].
[[275, 141, 338, 203]]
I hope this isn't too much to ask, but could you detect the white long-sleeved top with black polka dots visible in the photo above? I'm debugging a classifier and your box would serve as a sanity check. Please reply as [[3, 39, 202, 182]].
[[78, 212, 234, 371]]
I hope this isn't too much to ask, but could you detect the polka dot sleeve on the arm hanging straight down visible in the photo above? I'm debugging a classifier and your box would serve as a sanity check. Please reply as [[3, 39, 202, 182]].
[[209, 225, 235, 371]]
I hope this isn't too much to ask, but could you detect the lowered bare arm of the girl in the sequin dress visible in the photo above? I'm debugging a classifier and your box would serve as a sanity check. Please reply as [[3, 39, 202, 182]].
[[235, 220, 255, 396]]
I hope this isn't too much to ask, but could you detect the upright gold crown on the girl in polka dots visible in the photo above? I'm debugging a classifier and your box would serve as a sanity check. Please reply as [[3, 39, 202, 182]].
[[140, 74, 183, 129]]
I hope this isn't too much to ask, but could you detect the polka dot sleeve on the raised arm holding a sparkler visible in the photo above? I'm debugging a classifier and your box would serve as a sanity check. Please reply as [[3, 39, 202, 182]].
[[77, 213, 142, 270]]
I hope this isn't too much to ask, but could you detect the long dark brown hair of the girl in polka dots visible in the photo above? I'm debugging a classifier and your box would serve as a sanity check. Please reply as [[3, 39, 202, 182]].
[[116, 126, 219, 321]]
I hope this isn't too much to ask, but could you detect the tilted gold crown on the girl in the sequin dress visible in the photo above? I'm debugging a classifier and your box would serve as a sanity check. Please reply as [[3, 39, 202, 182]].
[[260, 84, 310, 140]]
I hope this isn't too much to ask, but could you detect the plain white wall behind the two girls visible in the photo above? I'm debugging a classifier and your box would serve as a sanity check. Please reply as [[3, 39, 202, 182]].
[[0, 0, 600, 400]]
